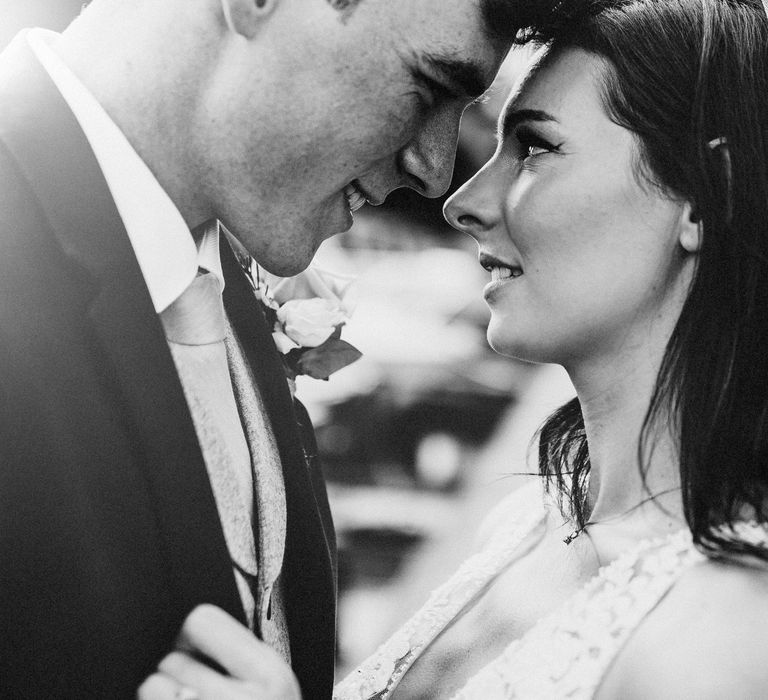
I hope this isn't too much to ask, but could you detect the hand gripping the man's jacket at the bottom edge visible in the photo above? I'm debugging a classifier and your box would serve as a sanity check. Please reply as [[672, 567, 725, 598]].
[[136, 605, 301, 700]]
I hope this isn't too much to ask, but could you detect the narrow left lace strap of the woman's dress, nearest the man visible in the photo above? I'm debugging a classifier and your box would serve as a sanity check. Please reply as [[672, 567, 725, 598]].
[[333, 483, 545, 700]]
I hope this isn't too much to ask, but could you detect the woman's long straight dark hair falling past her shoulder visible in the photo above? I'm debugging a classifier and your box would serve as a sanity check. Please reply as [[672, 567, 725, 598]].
[[517, 0, 768, 559]]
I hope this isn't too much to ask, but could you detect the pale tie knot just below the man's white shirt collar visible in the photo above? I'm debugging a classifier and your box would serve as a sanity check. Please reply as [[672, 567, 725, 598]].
[[160, 272, 226, 345]]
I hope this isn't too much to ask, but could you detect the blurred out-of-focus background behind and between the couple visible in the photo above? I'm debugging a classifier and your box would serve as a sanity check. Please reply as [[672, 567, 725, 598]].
[[0, 0, 573, 676]]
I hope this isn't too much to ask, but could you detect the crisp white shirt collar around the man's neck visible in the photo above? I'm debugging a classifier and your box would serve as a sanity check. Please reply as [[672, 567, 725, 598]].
[[26, 29, 224, 313]]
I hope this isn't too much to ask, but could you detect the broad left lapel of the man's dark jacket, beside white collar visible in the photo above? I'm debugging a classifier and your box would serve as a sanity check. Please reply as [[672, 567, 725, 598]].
[[0, 45, 244, 624]]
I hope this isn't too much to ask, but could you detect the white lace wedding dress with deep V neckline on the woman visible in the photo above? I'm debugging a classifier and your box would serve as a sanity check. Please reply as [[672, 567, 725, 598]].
[[333, 485, 768, 700]]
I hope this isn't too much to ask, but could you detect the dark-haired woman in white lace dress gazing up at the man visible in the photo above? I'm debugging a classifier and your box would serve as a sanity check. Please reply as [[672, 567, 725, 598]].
[[336, 0, 768, 700]]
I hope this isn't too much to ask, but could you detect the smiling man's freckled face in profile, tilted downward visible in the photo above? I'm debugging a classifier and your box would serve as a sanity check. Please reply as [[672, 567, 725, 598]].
[[193, 0, 508, 275]]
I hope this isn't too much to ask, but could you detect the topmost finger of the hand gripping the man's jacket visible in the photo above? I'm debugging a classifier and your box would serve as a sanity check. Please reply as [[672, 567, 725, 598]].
[[177, 605, 290, 681]]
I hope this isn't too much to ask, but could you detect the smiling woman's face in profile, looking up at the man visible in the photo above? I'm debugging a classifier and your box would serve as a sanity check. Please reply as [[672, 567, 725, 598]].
[[445, 49, 696, 367]]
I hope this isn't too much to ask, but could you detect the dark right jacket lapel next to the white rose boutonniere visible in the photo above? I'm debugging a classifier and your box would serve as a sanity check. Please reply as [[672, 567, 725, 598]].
[[221, 236, 336, 697]]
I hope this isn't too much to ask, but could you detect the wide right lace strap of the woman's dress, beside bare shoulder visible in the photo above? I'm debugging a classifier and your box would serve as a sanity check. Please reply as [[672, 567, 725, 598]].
[[454, 530, 705, 700]]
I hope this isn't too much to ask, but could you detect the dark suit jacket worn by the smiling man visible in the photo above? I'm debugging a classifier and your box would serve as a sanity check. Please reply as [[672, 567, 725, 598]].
[[0, 39, 336, 699]]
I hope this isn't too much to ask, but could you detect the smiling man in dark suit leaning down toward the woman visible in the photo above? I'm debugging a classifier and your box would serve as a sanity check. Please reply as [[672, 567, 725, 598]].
[[0, 0, 511, 698]]
